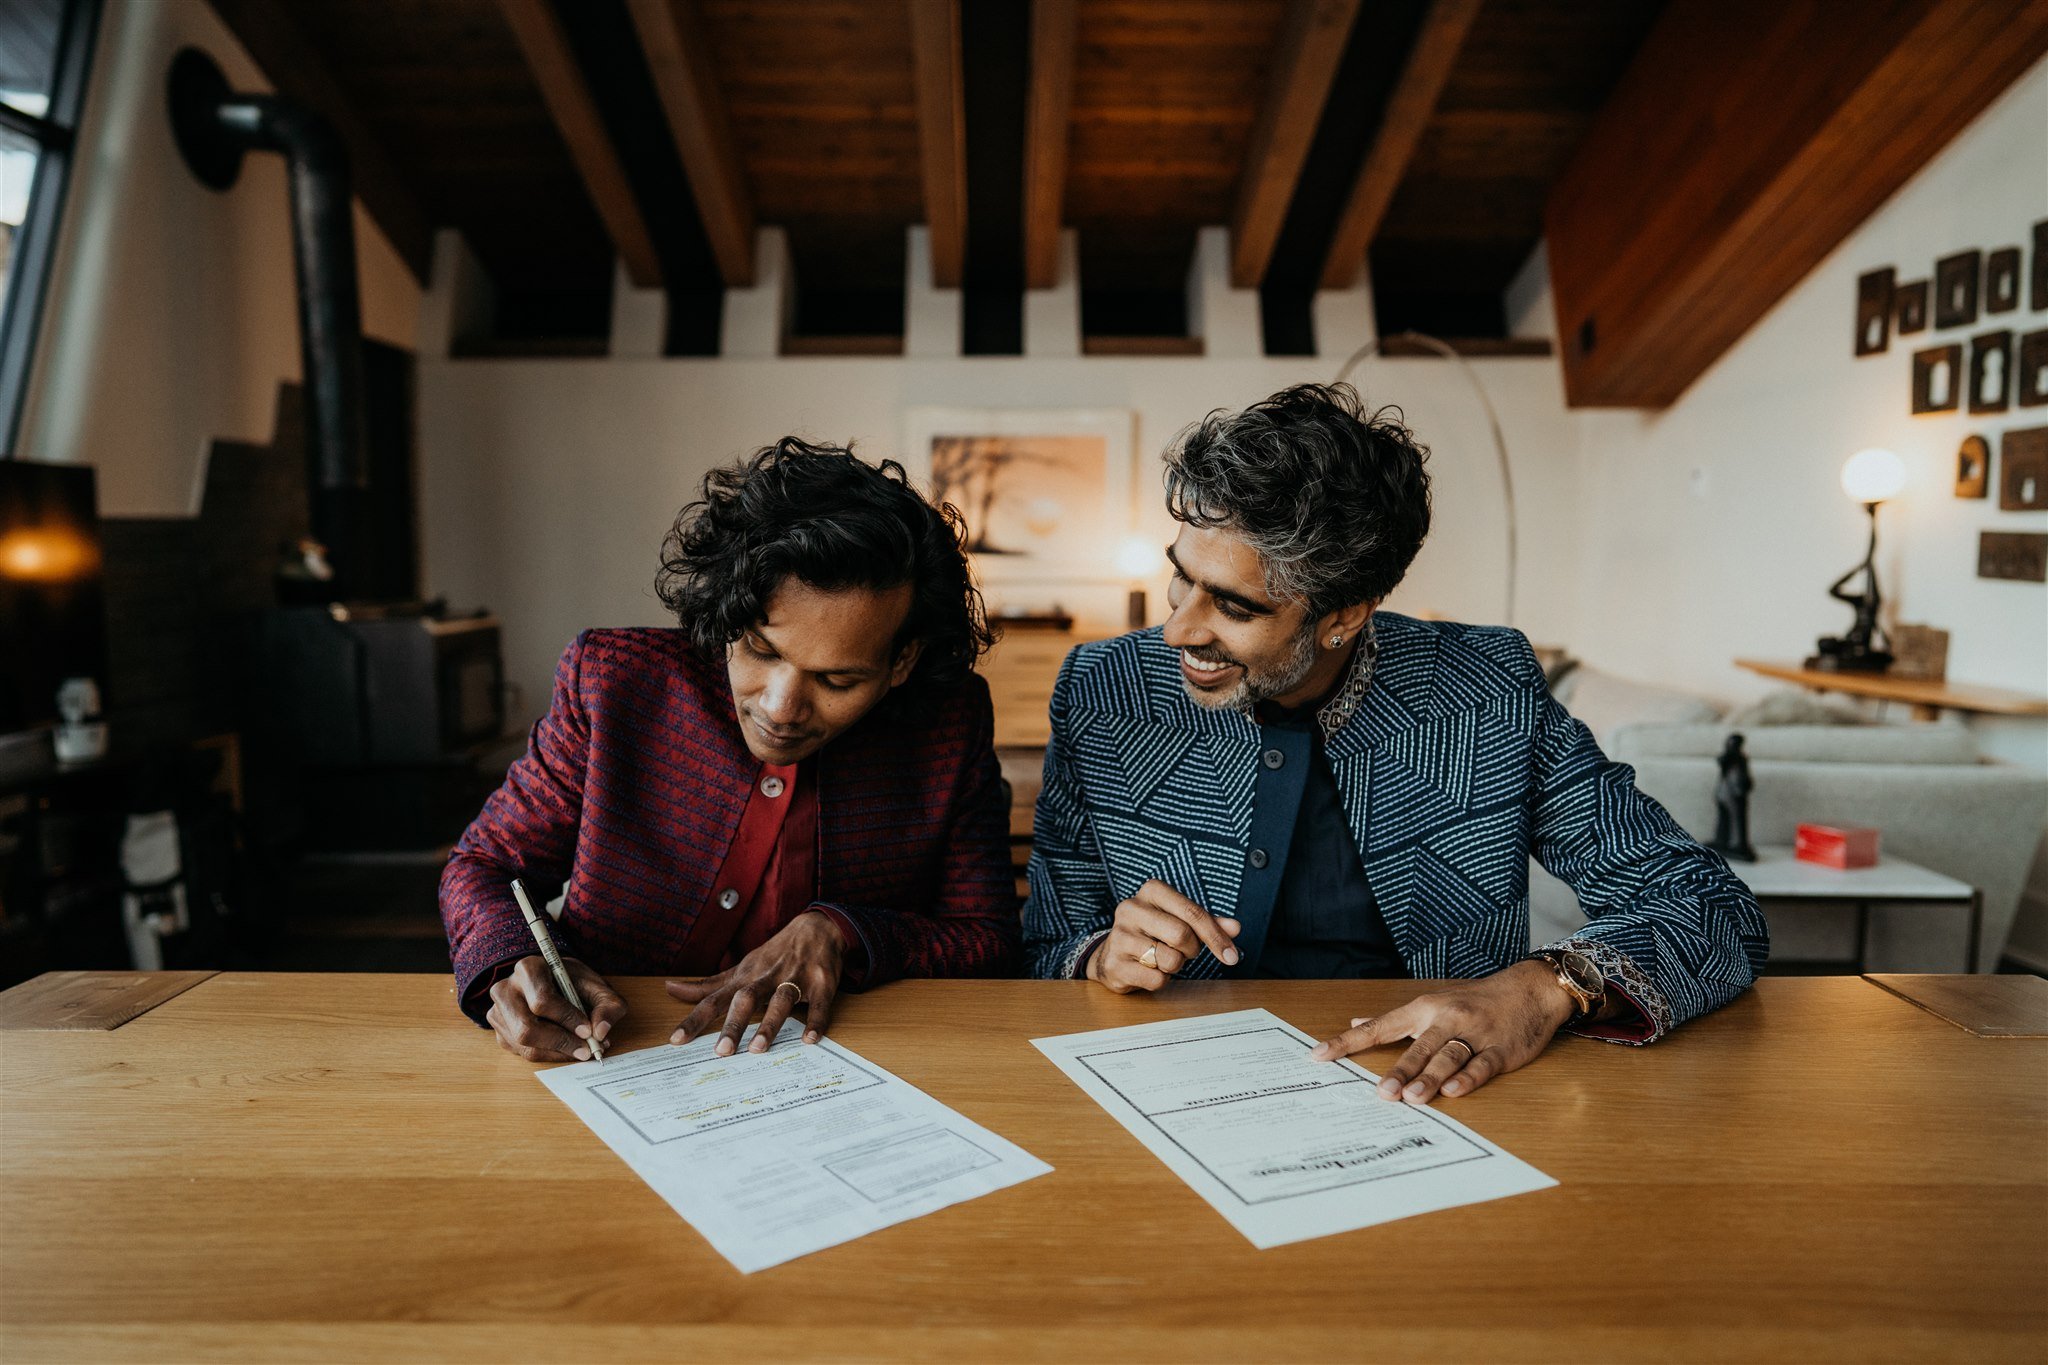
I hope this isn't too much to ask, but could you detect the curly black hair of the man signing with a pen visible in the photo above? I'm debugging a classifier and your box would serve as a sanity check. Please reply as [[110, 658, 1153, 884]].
[[655, 436, 993, 686]]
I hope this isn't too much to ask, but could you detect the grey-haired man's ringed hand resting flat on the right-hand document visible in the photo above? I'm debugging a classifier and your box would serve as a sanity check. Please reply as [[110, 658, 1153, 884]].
[[1309, 962, 1573, 1105]]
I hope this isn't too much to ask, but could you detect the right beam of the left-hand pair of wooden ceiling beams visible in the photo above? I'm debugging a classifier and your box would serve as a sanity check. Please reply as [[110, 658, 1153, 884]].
[[627, 0, 754, 289]]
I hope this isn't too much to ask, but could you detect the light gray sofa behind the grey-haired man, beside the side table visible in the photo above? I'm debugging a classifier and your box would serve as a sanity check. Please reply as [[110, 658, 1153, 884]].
[[1530, 665, 2048, 972]]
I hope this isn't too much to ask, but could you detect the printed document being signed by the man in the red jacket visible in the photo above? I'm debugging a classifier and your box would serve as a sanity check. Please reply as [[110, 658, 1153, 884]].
[[539, 1019, 1051, 1271]]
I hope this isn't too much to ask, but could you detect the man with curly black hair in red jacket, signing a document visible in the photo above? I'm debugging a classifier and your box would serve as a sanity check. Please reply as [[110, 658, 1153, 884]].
[[440, 438, 1018, 1062]]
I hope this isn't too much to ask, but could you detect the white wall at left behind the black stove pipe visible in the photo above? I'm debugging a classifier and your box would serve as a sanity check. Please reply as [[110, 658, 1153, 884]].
[[20, 0, 420, 516]]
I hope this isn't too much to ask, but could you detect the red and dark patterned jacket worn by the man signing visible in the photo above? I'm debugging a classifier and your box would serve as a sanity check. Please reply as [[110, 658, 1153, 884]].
[[440, 628, 1020, 1021]]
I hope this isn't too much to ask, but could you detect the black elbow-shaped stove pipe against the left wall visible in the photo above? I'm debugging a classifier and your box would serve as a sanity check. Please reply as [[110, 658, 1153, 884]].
[[170, 47, 369, 489]]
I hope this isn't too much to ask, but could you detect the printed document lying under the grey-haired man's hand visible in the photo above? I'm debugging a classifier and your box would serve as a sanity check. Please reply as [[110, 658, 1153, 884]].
[[1034, 1009, 1556, 1248]]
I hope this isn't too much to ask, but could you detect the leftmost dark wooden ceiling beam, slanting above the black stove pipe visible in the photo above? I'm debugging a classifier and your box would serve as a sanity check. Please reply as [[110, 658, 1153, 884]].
[[213, 0, 434, 284]]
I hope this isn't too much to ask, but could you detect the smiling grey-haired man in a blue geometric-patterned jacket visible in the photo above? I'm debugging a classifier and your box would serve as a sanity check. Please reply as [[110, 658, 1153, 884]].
[[1024, 385, 1769, 1103]]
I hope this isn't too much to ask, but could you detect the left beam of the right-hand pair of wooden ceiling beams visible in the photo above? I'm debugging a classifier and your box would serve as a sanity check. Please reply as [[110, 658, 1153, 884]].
[[1231, 0, 1358, 289]]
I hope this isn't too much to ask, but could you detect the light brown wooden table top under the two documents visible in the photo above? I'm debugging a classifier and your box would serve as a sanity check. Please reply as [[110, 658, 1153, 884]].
[[0, 972, 2048, 1365]]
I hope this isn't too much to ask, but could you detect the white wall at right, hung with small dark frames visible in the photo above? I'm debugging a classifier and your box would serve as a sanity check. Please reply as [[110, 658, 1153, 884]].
[[1575, 61, 2048, 964]]
